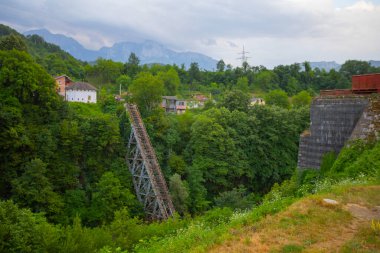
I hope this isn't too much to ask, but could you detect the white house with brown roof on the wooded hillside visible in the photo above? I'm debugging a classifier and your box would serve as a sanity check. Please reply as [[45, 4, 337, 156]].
[[66, 82, 96, 103]]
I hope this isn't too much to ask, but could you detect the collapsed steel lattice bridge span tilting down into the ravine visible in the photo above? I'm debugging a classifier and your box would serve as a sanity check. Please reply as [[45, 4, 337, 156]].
[[125, 104, 175, 220]]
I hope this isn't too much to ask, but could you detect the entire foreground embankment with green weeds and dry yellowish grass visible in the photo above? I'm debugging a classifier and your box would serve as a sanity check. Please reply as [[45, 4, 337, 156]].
[[131, 141, 380, 252]]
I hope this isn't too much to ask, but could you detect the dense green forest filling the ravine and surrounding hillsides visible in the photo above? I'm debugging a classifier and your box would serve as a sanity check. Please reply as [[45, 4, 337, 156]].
[[0, 25, 379, 252]]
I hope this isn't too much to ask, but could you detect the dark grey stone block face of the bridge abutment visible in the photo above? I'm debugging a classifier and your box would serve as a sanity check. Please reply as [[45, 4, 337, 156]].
[[298, 96, 370, 169]]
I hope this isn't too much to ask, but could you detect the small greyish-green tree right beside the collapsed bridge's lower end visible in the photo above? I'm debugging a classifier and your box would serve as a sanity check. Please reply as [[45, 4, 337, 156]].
[[169, 173, 189, 214]]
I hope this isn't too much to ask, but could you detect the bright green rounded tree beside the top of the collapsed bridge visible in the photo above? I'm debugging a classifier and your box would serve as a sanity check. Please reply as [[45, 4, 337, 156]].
[[129, 72, 164, 115]]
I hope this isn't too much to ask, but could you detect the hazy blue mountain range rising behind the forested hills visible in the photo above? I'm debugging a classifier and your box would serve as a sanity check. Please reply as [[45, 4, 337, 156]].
[[24, 29, 217, 70]]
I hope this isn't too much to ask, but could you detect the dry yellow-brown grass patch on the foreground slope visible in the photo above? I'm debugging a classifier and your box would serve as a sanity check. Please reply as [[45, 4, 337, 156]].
[[210, 186, 380, 253]]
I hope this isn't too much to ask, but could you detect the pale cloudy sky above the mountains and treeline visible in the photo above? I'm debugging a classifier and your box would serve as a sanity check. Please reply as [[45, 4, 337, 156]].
[[0, 0, 380, 67]]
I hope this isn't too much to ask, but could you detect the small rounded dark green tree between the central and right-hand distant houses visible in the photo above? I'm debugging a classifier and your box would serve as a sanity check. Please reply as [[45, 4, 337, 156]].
[[220, 90, 250, 112]]
